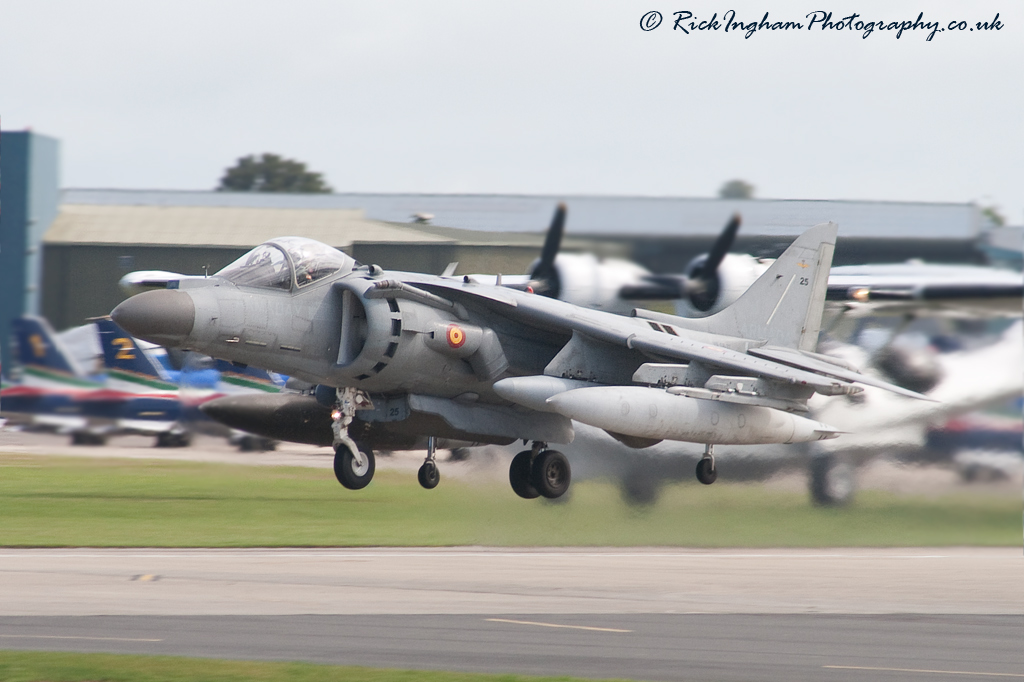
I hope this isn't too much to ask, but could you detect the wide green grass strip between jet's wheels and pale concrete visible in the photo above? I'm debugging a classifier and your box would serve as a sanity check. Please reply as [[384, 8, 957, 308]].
[[0, 455, 1021, 548]]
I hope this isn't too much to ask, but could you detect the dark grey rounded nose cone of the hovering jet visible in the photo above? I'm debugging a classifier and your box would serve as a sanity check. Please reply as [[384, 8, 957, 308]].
[[111, 289, 196, 346]]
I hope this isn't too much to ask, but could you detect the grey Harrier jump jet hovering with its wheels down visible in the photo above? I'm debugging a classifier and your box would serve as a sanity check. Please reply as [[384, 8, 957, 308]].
[[112, 223, 927, 498]]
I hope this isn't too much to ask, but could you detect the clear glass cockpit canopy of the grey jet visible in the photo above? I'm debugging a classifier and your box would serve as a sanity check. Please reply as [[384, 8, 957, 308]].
[[217, 237, 355, 291]]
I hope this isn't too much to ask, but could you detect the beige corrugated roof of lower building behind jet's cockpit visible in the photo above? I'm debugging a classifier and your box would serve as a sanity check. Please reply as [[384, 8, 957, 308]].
[[43, 203, 454, 248]]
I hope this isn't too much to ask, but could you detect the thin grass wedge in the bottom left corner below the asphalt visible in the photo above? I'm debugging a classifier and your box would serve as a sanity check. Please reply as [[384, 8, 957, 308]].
[[0, 651, 622, 682]]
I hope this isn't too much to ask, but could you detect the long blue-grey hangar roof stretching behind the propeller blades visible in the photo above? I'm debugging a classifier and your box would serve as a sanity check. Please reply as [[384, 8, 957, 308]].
[[63, 189, 983, 241]]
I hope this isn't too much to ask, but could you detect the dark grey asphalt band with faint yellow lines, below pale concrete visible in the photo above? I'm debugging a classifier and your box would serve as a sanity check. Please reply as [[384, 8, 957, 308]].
[[0, 613, 1024, 682]]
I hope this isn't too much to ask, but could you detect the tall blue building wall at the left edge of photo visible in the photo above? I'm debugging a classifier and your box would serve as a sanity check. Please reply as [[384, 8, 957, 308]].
[[0, 132, 60, 372]]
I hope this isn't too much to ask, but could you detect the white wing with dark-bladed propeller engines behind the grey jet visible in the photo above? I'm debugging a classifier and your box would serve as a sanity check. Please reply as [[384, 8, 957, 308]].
[[495, 204, 1024, 317]]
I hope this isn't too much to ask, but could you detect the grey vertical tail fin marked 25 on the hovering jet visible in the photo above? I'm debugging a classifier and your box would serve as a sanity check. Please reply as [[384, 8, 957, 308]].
[[678, 222, 839, 350]]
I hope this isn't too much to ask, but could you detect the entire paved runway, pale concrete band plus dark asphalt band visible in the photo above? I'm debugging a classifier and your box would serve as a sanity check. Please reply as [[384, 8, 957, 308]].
[[0, 548, 1024, 681]]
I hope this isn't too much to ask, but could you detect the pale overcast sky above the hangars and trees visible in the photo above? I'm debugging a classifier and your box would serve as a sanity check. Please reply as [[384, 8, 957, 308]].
[[0, 0, 1024, 224]]
